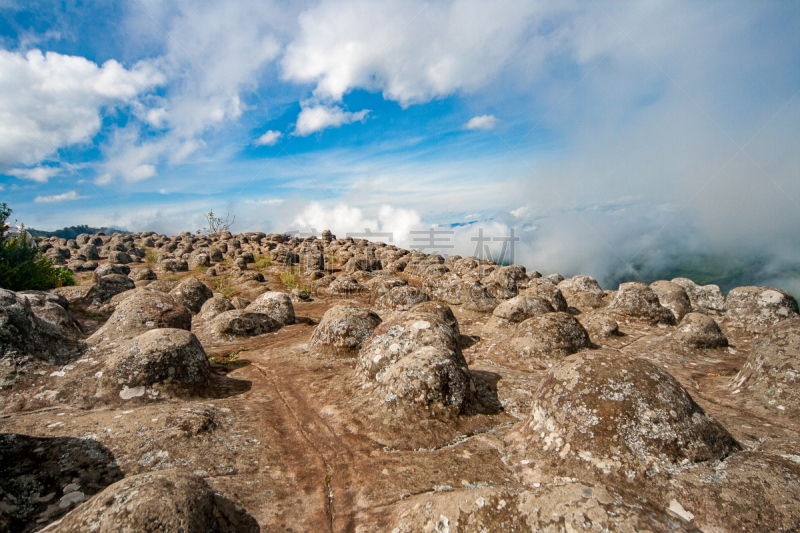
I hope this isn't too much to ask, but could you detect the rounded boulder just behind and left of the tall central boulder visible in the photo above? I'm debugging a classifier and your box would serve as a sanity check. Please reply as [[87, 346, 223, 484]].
[[309, 302, 381, 357]]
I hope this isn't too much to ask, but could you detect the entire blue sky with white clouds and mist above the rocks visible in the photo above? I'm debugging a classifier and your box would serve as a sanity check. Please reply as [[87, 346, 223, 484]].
[[0, 0, 800, 288]]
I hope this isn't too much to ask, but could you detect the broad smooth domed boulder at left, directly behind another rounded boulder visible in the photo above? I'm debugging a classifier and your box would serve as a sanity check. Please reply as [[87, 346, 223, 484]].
[[86, 289, 192, 346]]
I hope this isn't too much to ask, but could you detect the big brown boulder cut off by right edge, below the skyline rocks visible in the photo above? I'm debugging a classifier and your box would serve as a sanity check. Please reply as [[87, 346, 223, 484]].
[[731, 317, 800, 418]]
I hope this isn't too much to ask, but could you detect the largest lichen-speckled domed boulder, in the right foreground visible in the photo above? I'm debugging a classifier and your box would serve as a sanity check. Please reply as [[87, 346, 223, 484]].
[[506, 351, 741, 484]]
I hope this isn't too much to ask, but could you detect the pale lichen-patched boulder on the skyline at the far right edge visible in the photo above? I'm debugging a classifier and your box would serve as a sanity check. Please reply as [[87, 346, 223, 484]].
[[725, 287, 798, 333]]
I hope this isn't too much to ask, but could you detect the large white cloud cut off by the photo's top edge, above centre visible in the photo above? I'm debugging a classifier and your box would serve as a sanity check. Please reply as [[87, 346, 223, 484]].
[[282, 0, 565, 106]]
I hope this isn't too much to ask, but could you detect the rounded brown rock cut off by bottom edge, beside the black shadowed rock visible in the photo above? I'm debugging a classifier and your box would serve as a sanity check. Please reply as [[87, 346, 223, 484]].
[[42, 470, 260, 533]]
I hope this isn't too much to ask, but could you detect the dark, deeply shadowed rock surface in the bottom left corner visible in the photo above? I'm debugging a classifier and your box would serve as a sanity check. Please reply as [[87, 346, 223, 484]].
[[0, 433, 124, 533]]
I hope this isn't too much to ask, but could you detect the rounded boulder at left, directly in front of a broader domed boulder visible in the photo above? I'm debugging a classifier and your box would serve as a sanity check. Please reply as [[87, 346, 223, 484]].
[[100, 328, 211, 400]]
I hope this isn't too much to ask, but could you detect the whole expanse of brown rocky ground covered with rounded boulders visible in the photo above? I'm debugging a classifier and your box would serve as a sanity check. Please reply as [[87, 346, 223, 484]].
[[0, 232, 800, 533]]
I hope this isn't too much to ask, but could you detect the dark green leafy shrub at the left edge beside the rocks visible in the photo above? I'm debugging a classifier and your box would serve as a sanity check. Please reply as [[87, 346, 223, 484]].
[[0, 203, 75, 291]]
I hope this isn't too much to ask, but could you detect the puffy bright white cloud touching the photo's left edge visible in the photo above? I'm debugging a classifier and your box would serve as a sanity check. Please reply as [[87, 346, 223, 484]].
[[0, 50, 164, 166]]
